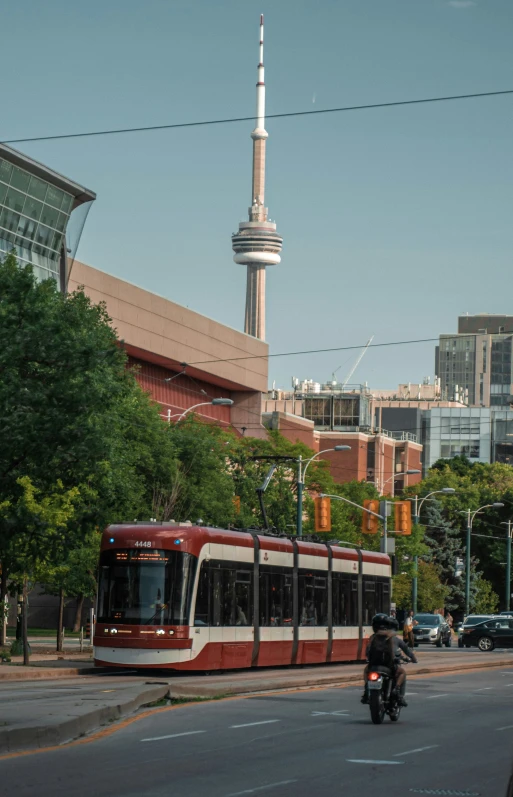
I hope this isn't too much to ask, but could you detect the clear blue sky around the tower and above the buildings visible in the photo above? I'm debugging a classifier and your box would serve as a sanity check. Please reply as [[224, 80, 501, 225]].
[[4, 0, 513, 387]]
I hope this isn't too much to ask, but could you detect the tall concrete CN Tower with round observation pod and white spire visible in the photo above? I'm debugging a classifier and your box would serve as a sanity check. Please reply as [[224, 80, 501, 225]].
[[232, 15, 283, 340]]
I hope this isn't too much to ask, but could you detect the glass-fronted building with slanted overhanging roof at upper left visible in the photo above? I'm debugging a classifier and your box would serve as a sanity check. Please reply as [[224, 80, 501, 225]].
[[0, 144, 96, 291]]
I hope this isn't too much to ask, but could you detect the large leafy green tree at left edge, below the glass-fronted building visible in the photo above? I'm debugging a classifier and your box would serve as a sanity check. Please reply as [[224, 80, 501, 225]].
[[0, 255, 177, 643]]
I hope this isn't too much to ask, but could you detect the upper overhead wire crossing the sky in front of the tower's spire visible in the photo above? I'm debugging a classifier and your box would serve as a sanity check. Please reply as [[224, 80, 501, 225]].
[[0, 89, 513, 144]]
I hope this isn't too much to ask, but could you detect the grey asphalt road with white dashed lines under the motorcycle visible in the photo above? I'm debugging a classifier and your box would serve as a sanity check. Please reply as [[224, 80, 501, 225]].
[[0, 667, 513, 797]]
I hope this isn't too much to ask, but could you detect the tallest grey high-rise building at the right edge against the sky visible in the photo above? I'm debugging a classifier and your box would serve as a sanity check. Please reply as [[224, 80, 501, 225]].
[[435, 313, 513, 407]]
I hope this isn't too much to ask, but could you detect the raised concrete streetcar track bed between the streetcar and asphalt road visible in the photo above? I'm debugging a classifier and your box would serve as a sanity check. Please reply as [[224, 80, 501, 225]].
[[0, 649, 513, 755]]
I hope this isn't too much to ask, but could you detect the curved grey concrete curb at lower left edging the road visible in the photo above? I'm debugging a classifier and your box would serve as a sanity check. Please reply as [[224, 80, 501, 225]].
[[0, 686, 169, 755]]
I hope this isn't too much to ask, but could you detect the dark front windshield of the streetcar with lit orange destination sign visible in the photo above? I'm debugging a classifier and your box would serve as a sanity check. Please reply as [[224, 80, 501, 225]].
[[98, 548, 197, 625]]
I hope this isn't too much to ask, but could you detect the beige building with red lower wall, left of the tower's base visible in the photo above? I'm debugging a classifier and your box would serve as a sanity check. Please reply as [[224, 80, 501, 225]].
[[69, 261, 268, 437]]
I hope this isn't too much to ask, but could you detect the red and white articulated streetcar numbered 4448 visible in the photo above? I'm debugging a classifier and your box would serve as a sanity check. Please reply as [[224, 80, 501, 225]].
[[94, 522, 391, 670]]
